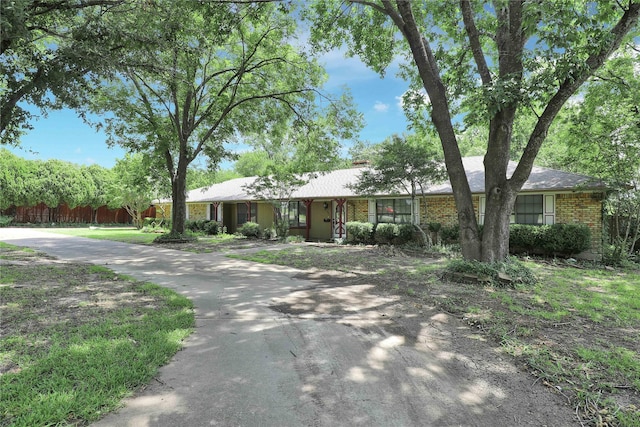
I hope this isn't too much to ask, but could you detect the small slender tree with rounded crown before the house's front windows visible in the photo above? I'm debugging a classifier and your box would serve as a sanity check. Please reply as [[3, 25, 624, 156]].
[[353, 135, 446, 242]]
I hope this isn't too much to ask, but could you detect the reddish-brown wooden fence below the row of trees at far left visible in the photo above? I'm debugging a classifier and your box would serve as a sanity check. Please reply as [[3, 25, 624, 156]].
[[0, 203, 156, 224]]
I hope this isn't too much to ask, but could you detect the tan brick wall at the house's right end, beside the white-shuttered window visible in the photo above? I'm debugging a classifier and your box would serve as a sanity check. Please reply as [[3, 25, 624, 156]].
[[556, 193, 604, 255]]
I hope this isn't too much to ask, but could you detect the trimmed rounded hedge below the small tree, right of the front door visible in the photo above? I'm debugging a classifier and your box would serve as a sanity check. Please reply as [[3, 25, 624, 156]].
[[346, 221, 413, 245]]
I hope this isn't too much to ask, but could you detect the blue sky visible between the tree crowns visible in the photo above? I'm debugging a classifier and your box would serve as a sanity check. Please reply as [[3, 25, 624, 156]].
[[10, 51, 408, 168]]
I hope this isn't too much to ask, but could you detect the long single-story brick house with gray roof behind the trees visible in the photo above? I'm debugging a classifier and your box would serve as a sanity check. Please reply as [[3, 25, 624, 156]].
[[156, 156, 606, 252]]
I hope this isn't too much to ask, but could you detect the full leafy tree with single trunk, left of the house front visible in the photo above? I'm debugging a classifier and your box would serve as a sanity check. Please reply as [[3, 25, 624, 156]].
[[93, 0, 358, 234]]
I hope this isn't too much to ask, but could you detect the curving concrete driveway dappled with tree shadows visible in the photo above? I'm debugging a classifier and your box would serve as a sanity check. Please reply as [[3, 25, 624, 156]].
[[0, 229, 577, 427]]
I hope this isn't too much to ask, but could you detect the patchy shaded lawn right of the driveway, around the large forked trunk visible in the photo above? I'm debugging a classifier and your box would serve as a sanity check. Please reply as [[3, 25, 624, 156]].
[[229, 245, 640, 426]]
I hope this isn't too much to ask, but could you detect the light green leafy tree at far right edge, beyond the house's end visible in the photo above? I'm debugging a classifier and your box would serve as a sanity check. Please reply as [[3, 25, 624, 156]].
[[563, 47, 640, 262]]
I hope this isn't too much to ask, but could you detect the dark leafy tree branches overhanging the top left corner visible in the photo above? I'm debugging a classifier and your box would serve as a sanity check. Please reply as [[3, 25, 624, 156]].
[[0, 0, 131, 145]]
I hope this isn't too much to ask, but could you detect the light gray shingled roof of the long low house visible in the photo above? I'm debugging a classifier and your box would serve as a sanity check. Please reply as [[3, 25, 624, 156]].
[[181, 156, 604, 202]]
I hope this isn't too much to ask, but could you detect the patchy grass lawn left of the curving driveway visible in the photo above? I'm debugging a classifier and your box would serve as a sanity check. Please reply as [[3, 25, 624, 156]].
[[0, 244, 195, 426]]
